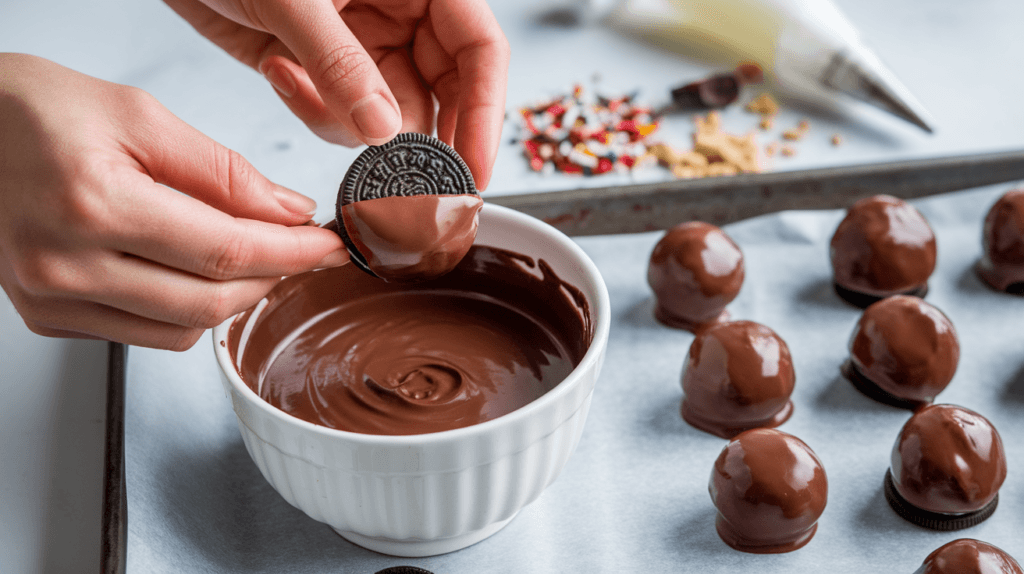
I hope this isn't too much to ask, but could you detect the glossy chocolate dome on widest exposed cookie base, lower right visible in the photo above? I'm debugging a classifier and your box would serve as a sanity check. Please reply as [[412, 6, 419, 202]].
[[890, 404, 1007, 515]]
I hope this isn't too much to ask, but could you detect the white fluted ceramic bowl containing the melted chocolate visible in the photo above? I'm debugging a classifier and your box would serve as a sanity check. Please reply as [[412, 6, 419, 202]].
[[213, 205, 610, 557]]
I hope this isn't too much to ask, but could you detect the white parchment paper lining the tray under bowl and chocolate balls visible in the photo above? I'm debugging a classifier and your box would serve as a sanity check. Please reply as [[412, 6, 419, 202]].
[[126, 186, 1024, 574]]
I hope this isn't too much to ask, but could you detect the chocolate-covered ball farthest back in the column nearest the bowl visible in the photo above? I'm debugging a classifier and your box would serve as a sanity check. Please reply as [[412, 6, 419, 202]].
[[647, 221, 743, 330]]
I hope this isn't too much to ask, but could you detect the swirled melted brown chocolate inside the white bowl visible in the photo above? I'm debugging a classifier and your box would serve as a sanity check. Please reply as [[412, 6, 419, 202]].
[[228, 246, 593, 435]]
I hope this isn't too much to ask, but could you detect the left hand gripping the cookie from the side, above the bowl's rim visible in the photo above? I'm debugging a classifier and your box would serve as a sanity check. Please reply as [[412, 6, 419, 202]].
[[0, 54, 347, 350]]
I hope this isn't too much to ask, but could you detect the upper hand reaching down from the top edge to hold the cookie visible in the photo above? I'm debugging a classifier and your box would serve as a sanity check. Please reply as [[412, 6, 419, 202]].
[[165, 0, 509, 189]]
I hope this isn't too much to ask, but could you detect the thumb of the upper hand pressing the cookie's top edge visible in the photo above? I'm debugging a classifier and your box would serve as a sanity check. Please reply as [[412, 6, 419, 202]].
[[266, 0, 401, 145]]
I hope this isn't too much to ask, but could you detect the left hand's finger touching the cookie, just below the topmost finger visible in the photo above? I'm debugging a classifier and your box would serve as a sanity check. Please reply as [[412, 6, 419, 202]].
[[113, 174, 348, 280]]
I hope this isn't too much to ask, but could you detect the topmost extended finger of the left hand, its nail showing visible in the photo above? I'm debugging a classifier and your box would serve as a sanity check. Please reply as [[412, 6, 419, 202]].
[[116, 96, 316, 225]]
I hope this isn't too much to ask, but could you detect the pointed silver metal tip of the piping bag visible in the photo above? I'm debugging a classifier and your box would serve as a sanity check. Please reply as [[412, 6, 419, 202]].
[[821, 52, 935, 134]]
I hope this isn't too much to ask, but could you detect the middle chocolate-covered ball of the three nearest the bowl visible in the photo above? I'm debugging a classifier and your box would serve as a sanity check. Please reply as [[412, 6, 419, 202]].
[[681, 321, 796, 438]]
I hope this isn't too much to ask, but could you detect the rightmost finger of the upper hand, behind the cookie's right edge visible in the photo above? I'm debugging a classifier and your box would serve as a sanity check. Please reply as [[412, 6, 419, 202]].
[[414, 0, 509, 189]]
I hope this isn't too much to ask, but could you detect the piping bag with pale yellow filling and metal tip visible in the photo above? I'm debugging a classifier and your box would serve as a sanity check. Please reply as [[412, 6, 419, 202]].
[[575, 0, 933, 133]]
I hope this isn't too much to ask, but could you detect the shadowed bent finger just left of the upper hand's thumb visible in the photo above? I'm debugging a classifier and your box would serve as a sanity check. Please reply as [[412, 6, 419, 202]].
[[258, 40, 362, 147]]
